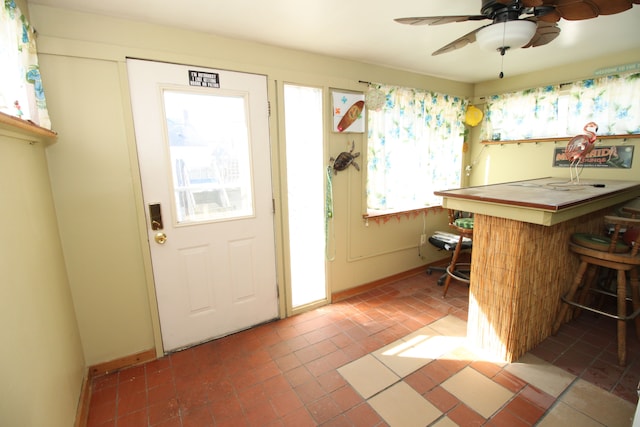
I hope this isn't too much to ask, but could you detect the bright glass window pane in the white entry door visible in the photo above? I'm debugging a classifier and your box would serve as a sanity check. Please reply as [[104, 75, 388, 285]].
[[164, 90, 254, 224]]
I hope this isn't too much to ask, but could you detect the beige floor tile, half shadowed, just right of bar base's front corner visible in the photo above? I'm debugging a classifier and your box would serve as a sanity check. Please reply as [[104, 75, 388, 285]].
[[505, 353, 576, 397]]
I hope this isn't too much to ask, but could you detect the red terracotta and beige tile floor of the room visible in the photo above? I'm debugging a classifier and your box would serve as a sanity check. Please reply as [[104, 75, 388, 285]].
[[88, 273, 640, 427]]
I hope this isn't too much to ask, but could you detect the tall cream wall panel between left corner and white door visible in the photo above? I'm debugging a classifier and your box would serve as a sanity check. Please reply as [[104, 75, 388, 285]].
[[40, 55, 154, 365]]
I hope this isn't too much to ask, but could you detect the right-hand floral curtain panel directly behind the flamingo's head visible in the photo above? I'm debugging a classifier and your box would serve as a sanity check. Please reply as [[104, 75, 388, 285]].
[[567, 73, 640, 135]]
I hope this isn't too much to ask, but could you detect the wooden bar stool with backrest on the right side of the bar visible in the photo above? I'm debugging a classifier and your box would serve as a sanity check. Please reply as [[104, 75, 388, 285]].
[[553, 208, 640, 366]]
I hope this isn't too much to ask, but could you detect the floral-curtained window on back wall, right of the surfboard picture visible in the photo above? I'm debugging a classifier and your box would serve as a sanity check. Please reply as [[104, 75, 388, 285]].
[[367, 86, 467, 215]]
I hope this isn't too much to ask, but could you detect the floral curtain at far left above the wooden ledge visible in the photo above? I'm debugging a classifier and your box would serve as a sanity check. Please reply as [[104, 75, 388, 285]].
[[0, 0, 51, 129]]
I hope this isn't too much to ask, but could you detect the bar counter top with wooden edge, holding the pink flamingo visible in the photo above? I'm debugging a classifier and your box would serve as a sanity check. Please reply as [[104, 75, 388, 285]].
[[435, 177, 640, 225]]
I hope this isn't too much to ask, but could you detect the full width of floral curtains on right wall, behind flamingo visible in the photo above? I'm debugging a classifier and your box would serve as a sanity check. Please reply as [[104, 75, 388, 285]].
[[481, 73, 640, 140]]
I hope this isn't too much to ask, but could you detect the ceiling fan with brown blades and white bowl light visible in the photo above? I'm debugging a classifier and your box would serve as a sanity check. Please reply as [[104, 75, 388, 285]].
[[395, 0, 640, 55]]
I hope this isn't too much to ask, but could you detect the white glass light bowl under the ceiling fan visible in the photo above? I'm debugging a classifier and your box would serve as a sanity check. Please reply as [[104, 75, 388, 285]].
[[476, 19, 537, 51]]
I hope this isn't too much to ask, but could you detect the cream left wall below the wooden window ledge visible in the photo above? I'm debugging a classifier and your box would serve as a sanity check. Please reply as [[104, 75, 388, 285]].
[[0, 130, 85, 427]]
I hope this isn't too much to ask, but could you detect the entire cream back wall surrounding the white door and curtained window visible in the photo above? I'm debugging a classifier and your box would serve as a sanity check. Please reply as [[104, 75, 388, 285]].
[[31, 5, 472, 365]]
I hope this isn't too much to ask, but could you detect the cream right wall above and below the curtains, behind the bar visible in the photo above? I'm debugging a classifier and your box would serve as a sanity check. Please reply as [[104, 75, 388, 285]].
[[467, 49, 640, 185]]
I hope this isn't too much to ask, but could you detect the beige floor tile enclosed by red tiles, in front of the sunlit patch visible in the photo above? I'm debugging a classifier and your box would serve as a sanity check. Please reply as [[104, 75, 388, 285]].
[[442, 367, 513, 418]]
